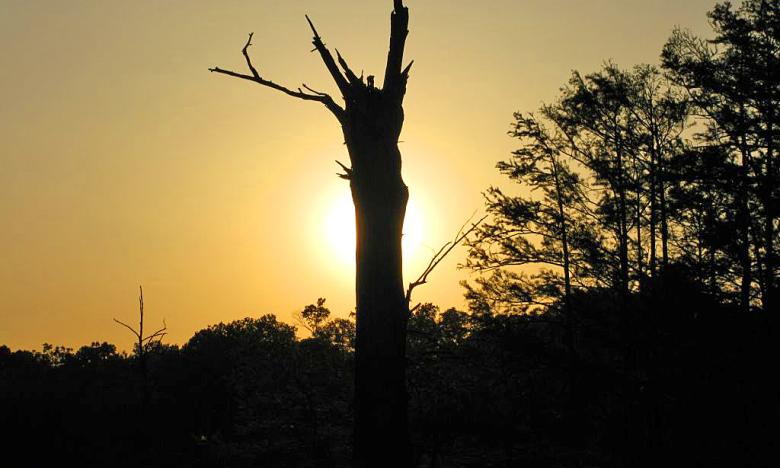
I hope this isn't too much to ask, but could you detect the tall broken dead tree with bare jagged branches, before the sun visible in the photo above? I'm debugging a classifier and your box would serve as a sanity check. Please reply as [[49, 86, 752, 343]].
[[210, 0, 412, 468]]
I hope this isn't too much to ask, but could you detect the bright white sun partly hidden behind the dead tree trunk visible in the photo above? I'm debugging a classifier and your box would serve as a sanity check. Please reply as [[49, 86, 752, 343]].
[[323, 192, 423, 265]]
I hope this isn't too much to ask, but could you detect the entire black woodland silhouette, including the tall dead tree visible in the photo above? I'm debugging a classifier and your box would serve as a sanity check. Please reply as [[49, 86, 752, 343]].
[[0, 0, 780, 467]]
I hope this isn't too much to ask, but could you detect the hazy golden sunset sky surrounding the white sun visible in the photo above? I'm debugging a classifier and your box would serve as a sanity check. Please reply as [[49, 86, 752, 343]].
[[0, 0, 714, 349]]
